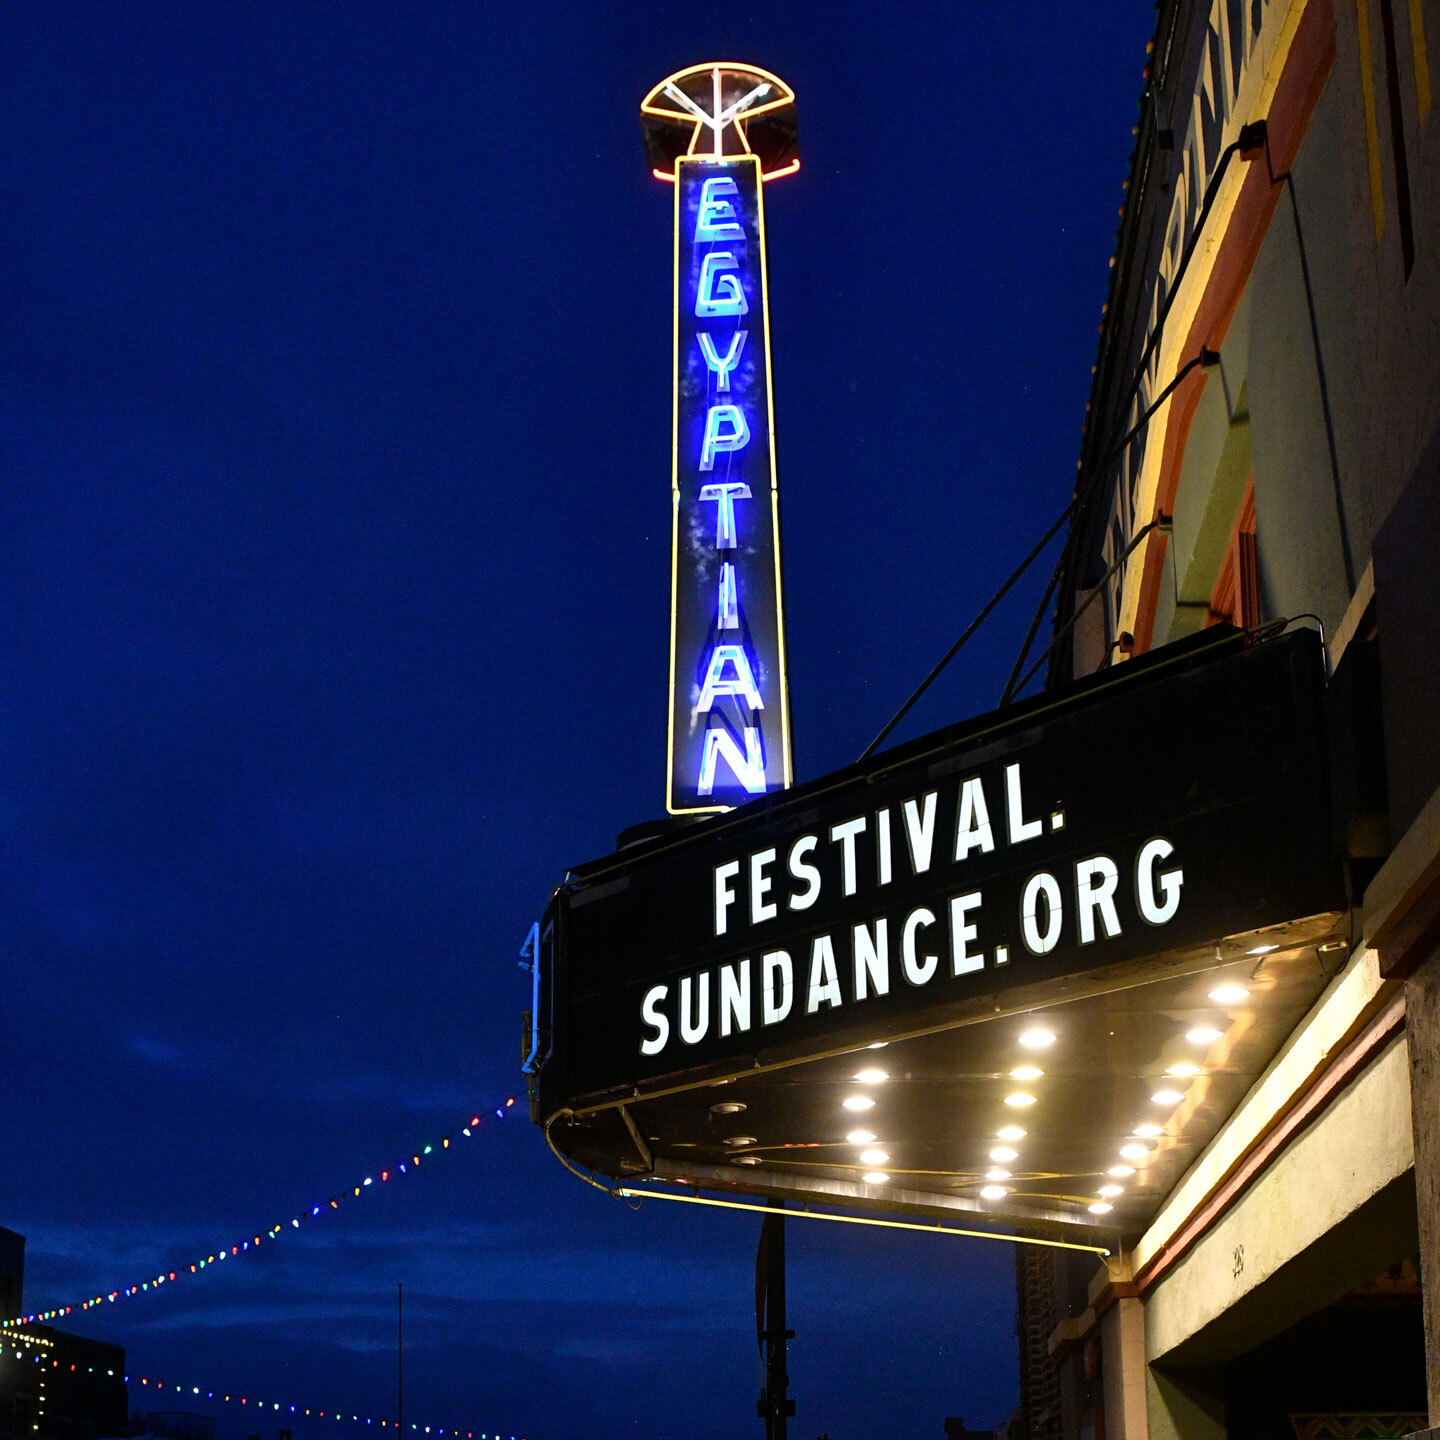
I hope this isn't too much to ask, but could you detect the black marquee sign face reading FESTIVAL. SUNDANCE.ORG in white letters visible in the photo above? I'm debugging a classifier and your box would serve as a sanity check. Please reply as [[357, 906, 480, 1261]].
[[541, 631, 1344, 1107]]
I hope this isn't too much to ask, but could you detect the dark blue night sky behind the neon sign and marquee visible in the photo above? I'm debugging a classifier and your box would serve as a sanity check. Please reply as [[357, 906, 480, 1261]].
[[0, 8, 1152, 1440]]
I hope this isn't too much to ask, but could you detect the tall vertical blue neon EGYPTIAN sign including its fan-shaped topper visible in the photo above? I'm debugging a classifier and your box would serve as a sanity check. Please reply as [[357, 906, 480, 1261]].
[[641, 65, 799, 815]]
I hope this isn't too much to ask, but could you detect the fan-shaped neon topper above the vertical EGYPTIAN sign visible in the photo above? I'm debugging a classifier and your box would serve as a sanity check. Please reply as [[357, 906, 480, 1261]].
[[639, 60, 801, 183]]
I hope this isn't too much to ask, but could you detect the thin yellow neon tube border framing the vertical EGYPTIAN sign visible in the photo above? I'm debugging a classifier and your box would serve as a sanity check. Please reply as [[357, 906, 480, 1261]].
[[665, 154, 795, 815]]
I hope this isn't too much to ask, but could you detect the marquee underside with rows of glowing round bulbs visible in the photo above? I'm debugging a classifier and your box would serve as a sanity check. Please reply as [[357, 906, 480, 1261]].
[[549, 912, 1342, 1237]]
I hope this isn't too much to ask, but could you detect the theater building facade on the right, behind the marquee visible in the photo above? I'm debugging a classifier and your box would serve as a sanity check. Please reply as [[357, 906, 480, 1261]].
[[1015, 0, 1440, 1440]]
